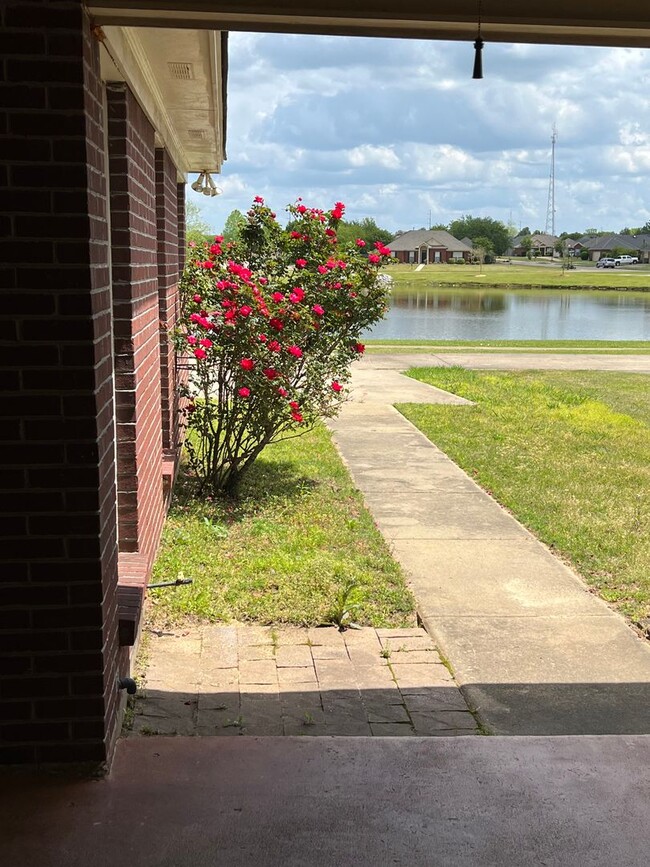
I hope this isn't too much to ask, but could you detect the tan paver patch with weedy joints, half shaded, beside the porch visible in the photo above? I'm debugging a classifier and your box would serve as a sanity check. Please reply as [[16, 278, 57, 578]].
[[129, 625, 477, 737]]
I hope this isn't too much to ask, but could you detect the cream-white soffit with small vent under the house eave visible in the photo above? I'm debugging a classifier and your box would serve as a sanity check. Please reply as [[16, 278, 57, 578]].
[[101, 27, 225, 175]]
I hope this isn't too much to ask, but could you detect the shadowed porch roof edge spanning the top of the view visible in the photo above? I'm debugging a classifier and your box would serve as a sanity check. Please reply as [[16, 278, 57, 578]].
[[88, 0, 650, 47]]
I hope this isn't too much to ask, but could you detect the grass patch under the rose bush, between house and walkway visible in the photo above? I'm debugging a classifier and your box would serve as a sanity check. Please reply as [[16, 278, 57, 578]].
[[150, 427, 414, 626]]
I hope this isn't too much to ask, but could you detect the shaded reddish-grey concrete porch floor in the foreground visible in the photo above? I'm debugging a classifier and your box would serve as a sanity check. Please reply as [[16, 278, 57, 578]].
[[0, 736, 650, 867]]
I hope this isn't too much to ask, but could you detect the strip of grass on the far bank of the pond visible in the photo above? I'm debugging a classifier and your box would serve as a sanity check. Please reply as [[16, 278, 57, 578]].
[[385, 262, 650, 293]]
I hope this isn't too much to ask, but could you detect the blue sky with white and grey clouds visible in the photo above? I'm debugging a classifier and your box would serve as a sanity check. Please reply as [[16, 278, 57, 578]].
[[188, 33, 650, 234]]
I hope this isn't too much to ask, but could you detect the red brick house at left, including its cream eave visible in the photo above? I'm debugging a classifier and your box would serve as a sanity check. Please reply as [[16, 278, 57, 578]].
[[0, 0, 226, 763]]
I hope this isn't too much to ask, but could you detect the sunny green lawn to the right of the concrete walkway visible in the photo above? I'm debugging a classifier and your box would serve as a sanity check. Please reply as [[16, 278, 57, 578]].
[[399, 368, 650, 620]]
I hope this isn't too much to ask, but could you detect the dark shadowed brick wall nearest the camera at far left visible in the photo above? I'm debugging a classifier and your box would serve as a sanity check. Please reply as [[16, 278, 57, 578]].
[[0, 0, 118, 763]]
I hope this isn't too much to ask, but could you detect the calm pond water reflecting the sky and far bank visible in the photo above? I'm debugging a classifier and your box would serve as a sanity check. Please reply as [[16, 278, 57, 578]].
[[366, 288, 650, 340]]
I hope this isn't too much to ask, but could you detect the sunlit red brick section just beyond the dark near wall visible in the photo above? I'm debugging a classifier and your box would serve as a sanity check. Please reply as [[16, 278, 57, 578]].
[[107, 82, 163, 566]]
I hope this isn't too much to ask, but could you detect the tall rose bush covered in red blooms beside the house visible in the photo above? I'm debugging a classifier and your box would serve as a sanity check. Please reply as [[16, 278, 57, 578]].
[[176, 196, 390, 493]]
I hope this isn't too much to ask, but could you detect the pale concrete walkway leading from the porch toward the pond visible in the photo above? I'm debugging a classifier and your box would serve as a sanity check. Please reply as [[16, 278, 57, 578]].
[[331, 355, 650, 735]]
